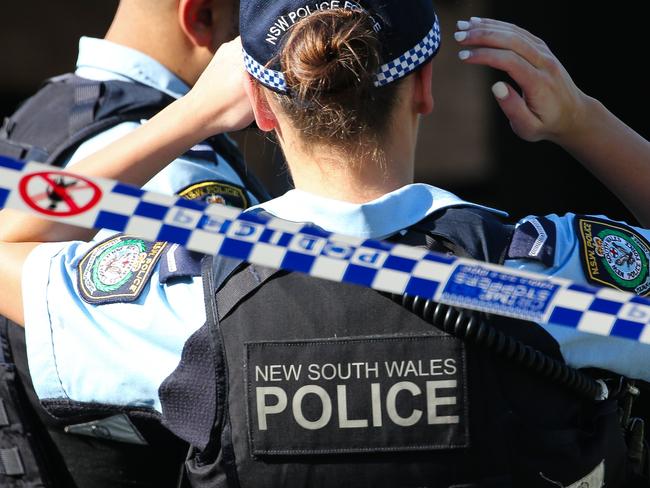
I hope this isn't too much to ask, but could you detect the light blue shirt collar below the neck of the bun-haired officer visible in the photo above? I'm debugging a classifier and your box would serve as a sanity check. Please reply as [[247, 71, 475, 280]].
[[256, 183, 508, 239]]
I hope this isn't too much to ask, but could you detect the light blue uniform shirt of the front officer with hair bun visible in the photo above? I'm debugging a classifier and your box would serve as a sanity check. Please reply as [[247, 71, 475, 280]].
[[23, 184, 650, 411]]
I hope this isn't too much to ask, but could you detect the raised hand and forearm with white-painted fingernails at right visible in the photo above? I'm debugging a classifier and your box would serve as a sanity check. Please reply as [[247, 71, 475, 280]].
[[455, 17, 650, 228]]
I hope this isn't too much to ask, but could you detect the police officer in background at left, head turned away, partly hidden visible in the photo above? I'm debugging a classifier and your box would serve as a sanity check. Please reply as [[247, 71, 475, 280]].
[[0, 0, 266, 487]]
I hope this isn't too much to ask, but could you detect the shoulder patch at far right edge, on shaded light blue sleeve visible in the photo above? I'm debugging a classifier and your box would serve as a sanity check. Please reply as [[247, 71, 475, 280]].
[[575, 216, 650, 296]]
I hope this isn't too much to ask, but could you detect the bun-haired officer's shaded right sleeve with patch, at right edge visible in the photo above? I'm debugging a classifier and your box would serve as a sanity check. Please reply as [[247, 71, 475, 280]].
[[505, 214, 650, 381]]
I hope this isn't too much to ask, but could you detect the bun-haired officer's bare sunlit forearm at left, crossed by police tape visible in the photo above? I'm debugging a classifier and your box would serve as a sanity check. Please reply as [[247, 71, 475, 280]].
[[0, 97, 210, 242]]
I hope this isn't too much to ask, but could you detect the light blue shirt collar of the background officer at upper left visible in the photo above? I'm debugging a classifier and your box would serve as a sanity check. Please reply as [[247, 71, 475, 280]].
[[77, 37, 190, 98]]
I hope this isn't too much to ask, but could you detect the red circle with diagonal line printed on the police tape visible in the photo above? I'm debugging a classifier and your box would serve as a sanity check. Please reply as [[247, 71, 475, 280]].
[[18, 171, 102, 217]]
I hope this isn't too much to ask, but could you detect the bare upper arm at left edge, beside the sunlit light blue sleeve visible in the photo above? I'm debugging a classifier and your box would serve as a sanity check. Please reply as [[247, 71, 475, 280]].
[[0, 242, 38, 325]]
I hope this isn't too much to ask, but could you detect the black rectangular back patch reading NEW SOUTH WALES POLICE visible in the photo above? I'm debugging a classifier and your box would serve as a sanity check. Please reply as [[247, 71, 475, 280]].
[[245, 335, 469, 456]]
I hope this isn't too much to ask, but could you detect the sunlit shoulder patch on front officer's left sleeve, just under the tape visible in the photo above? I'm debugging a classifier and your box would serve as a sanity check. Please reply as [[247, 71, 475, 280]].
[[77, 235, 167, 305]]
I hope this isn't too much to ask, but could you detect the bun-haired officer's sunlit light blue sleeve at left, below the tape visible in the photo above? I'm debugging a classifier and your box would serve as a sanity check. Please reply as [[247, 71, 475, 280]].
[[23, 242, 205, 412]]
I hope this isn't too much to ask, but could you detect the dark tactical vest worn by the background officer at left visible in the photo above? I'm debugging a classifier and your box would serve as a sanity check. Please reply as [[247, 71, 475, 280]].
[[0, 75, 268, 488]]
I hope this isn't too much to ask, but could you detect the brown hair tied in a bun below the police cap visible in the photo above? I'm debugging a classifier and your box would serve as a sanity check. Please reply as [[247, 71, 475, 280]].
[[268, 9, 399, 154]]
